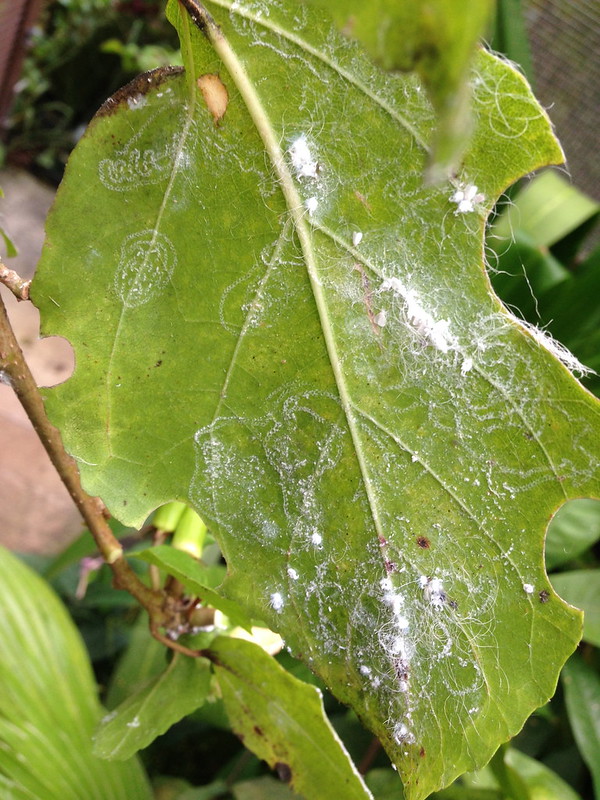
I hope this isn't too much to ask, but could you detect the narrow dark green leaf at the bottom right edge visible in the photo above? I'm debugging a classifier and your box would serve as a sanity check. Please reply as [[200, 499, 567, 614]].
[[562, 655, 600, 798]]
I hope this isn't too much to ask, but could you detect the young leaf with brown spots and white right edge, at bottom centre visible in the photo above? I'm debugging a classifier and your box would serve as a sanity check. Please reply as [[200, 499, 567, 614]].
[[209, 636, 372, 800]]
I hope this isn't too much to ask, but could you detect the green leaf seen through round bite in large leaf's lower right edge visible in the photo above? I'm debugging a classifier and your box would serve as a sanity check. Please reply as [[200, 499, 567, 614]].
[[546, 500, 600, 572]]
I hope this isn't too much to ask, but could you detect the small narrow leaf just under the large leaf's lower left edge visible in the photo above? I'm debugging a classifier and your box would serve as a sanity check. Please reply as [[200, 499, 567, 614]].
[[135, 544, 252, 632]]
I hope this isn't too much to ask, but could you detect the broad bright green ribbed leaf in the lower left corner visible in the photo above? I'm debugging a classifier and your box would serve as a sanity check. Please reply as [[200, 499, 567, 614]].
[[0, 549, 152, 800]]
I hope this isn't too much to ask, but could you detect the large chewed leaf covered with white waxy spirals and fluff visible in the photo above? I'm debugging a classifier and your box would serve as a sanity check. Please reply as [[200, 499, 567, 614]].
[[34, 0, 600, 800]]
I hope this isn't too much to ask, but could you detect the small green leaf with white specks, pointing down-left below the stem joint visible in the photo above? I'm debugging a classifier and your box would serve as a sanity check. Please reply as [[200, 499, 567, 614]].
[[94, 653, 211, 761]]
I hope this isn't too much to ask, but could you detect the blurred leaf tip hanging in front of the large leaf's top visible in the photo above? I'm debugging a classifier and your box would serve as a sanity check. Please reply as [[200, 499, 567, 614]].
[[312, 0, 494, 182]]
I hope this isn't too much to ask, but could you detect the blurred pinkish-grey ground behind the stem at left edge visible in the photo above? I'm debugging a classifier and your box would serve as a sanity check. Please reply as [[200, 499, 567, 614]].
[[0, 169, 82, 554]]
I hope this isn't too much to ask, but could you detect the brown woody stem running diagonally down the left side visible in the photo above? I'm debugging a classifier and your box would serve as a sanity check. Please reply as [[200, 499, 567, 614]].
[[0, 298, 164, 612]]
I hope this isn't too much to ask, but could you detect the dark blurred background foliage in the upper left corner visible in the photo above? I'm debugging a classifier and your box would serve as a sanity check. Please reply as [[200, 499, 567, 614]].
[[2, 0, 181, 183]]
